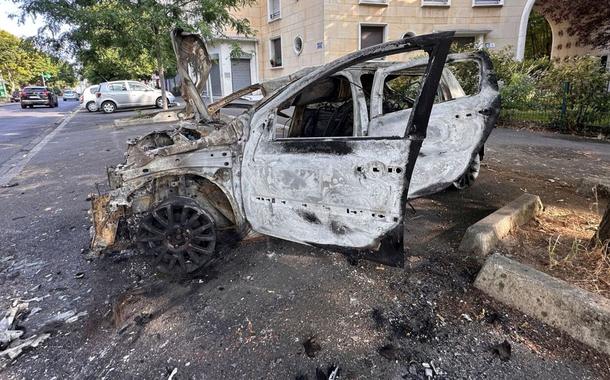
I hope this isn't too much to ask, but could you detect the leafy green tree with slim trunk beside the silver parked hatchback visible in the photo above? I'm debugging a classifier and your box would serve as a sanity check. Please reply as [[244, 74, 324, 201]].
[[16, 0, 255, 109]]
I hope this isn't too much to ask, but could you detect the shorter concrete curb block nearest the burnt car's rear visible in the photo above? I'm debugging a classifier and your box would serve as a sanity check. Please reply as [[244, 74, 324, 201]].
[[459, 194, 543, 257]]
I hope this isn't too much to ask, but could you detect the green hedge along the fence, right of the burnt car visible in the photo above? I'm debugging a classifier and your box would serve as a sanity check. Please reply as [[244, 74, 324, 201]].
[[491, 50, 610, 131]]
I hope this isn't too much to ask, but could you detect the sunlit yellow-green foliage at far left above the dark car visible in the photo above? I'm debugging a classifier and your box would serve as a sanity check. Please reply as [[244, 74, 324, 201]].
[[0, 30, 76, 91]]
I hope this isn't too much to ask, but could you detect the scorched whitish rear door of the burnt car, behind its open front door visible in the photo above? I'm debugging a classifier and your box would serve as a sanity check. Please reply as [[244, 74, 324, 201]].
[[367, 51, 500, 199]]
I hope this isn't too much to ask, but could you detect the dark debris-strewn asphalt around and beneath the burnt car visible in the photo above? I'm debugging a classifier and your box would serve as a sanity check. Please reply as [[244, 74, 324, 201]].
[[0, 109, 610, 379]]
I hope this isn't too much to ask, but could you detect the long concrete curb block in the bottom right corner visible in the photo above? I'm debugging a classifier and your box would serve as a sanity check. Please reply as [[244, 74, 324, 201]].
[[474, 254, 610, 355]]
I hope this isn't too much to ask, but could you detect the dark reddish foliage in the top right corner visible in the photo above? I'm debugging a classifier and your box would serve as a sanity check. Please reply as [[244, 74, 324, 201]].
[[537, 0, 610, 49]]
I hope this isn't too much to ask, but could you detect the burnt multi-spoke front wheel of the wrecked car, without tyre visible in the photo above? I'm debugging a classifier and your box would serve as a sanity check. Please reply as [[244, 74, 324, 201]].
[[137, 197, 216, 275]]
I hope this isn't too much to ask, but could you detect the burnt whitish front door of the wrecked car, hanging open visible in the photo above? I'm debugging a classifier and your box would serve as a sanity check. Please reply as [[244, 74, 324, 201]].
[[241, 34, 451, 258]]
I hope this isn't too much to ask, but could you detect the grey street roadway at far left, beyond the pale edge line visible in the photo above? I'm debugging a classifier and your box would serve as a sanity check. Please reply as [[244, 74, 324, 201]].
[[0, 99, 80, 174]]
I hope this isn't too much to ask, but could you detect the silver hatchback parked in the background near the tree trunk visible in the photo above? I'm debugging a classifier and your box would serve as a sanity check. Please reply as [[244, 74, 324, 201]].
[[95, 80, 176, 113]]
